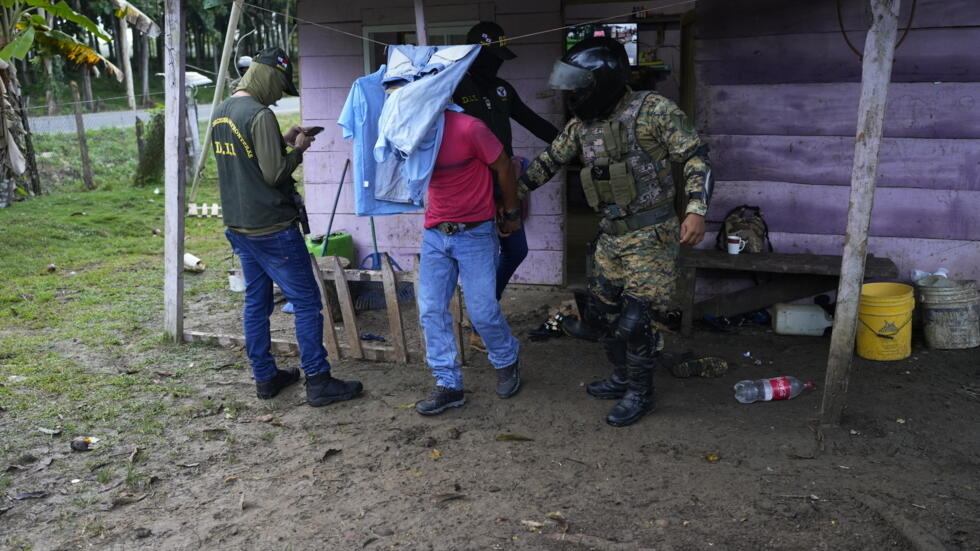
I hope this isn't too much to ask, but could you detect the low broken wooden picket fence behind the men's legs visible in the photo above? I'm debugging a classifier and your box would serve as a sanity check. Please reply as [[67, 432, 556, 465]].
[[184, 253, 466, 365]]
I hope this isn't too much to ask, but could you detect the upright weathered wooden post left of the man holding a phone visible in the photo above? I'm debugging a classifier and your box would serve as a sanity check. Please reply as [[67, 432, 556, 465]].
[[163, 0, 187, 342]]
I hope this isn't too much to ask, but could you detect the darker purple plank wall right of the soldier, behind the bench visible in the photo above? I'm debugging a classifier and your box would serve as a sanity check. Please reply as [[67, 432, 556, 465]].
[[695, 0, 980, 280]]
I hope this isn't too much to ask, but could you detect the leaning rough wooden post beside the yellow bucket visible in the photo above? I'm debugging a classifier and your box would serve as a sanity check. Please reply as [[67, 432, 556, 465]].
[[820, 0, 900, 425]]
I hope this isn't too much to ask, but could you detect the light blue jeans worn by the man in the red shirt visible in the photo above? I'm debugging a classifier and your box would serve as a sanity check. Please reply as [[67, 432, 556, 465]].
[[418, 221, 520, 389]]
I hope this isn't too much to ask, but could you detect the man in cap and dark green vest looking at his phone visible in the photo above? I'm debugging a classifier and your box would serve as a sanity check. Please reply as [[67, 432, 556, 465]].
[[211, 48, 362, 406]]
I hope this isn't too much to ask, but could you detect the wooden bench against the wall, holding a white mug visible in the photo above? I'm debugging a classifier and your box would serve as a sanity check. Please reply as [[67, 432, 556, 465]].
[[676, 248, 898, 335]]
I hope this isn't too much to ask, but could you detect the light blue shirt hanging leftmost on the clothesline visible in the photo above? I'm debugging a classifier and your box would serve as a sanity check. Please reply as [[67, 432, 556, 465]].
[[337, 65, 418, 216]]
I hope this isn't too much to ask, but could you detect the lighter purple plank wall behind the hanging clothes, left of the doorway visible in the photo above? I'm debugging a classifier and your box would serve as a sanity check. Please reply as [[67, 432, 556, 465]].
[[297, 0, 564, 284]]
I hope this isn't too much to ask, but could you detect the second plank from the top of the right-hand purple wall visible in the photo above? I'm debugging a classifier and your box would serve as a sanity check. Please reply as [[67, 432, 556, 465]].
[[695, 27, 980, 84]]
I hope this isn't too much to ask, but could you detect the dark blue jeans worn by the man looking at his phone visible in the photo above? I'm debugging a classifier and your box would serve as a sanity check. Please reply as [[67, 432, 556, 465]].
[[225, 227, 330, 381]]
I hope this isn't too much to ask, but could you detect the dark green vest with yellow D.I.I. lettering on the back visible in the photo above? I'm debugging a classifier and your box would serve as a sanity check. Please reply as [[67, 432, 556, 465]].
[[211, 97, 299, 229]]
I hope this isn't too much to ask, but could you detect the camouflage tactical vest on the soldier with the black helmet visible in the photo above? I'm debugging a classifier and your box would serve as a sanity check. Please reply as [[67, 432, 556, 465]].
[[580, 91, 674, 225]]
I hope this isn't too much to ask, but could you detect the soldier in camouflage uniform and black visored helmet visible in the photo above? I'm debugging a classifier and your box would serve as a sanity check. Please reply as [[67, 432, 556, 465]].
[[520, 38, 711, 426]]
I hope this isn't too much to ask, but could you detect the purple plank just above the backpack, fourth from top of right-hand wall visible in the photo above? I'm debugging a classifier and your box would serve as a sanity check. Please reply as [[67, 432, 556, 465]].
[[705, 135, 980, 191]]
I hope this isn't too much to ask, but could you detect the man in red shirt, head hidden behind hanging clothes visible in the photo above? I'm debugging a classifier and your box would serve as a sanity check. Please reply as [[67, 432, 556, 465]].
[[415, 111, 521, 415]]
